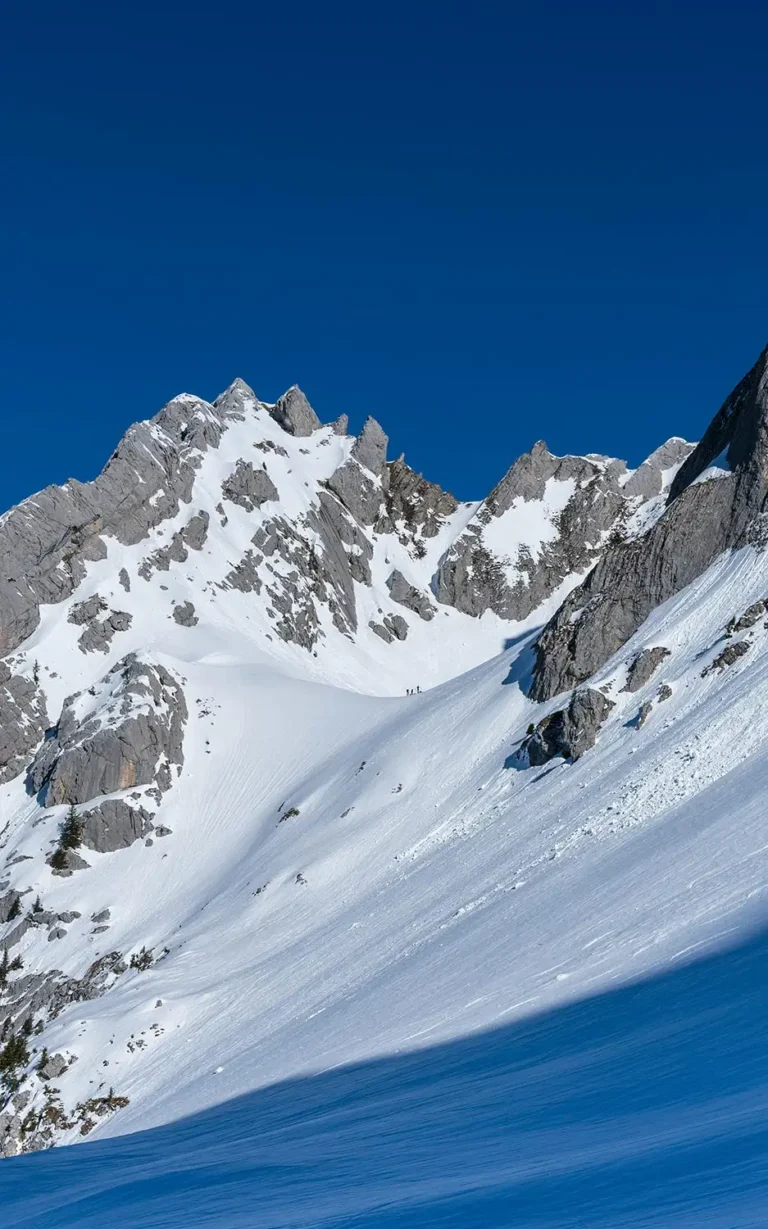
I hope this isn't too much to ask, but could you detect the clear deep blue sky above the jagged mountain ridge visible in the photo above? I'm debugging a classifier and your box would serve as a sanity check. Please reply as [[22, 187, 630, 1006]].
[[0, 0, 768, 506]]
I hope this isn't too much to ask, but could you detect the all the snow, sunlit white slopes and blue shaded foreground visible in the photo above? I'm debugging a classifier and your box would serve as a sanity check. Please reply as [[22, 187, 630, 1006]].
[[0, 380, 768, 1229]]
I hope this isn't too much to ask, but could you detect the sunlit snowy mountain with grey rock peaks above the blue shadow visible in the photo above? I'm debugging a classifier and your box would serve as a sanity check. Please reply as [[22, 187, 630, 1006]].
[[0, 355, 768, 1199]]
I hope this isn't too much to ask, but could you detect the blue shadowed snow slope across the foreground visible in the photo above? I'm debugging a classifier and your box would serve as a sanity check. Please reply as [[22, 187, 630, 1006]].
[[0, 935, 768, 1229]]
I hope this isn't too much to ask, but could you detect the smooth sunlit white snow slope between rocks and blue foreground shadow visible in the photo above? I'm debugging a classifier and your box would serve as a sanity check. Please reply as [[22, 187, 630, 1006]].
[[2, 549, 768, 1155]]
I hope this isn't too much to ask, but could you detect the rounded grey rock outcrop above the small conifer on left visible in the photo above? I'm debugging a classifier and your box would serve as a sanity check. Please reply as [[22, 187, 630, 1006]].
[[28, 654, 187, 806]]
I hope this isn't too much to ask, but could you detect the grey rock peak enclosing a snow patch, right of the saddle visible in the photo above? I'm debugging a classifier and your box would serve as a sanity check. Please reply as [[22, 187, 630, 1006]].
[[434, 440, 627, 619]]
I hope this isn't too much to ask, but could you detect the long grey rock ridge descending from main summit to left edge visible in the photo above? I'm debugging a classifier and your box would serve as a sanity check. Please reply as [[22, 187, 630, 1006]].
[[0, 395, 231, 654]]
